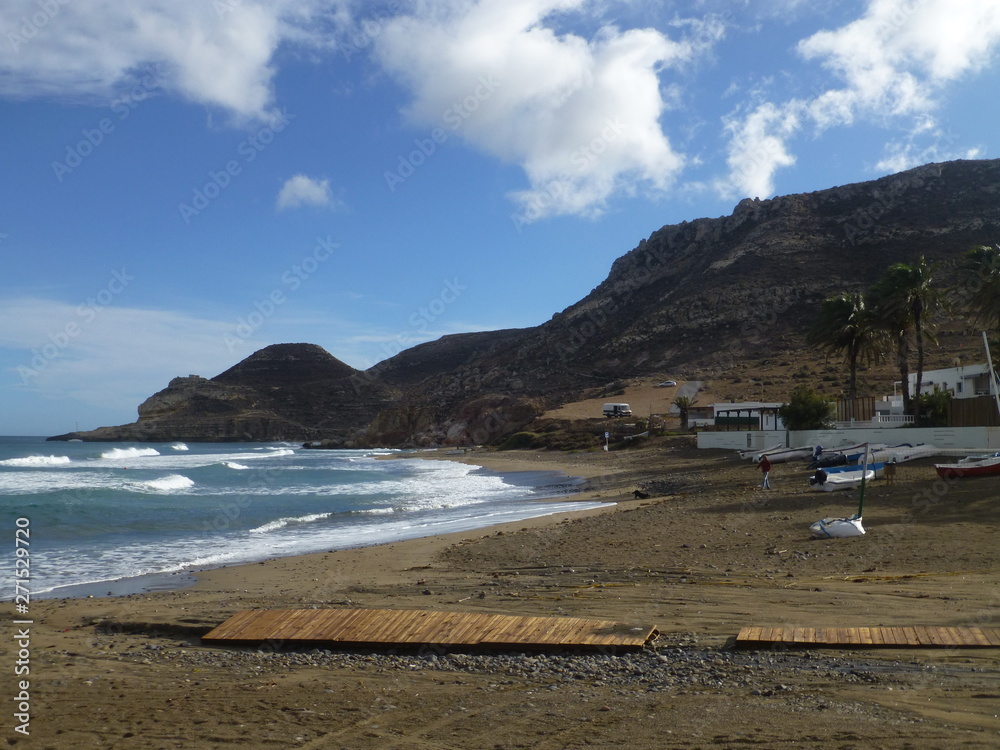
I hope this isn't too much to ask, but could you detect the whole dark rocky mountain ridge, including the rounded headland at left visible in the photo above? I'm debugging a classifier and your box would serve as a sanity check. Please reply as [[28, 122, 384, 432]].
[[48, 160, 1000, 445]]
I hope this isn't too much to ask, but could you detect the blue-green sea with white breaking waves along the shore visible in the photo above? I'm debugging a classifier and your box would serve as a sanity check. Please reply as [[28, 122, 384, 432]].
[[0, 437, 600, 598]]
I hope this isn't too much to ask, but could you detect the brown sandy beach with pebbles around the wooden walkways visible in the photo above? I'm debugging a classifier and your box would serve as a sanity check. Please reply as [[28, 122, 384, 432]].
[[15, 438, 1000, 750]]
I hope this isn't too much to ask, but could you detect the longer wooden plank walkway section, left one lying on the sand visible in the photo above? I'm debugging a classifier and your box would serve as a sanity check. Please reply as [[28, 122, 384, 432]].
[[201, 609, 657, 650]]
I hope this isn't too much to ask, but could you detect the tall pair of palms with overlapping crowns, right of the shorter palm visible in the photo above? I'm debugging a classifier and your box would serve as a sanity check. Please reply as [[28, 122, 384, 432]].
[[871, 255, 947, 424]]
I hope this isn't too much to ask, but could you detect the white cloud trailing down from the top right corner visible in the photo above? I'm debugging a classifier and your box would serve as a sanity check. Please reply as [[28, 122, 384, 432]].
[[720, 0, 1000, 196]]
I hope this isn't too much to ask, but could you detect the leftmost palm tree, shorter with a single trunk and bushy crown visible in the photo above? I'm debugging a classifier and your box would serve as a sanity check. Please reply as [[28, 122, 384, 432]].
[[806, 292, 885, 399]]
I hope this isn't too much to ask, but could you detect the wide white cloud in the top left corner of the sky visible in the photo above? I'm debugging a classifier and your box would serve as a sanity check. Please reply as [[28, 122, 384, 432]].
[[0, 0, 347, 118]]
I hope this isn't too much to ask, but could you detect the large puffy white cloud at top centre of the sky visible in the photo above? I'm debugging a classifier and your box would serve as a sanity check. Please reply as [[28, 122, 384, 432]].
[[376, 0, 721, 221]]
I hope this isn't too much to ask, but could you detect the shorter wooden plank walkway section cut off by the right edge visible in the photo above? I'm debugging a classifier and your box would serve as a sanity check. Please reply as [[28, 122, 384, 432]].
[[736, 627, 1000, 648]]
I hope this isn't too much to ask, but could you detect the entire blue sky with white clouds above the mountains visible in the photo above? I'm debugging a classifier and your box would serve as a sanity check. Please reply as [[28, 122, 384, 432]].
[[0, 0, 1000, 435]]
